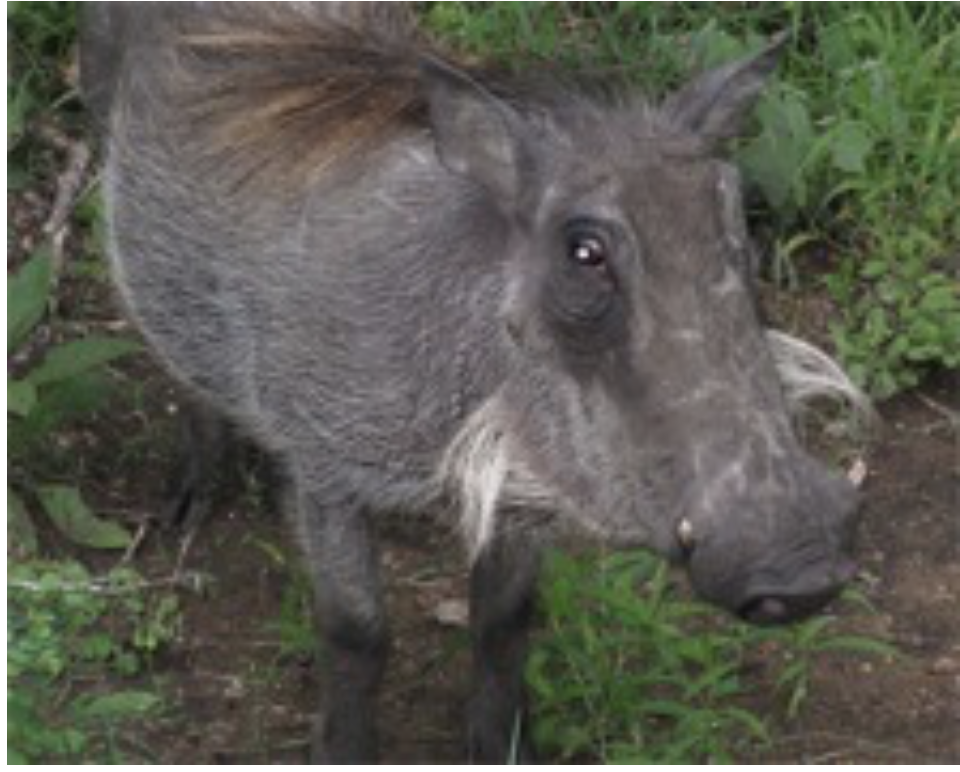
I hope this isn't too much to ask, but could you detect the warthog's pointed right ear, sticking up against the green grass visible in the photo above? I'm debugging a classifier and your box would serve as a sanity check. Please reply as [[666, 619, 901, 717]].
[[664, 33, 788, 141]]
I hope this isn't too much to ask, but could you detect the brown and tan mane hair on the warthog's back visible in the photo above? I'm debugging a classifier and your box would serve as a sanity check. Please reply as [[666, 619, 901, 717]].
[[172, 3, 429, 189]]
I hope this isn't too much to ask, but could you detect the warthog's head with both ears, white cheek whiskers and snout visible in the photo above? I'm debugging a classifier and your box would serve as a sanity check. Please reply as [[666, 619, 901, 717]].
[[436, 39, 856, 622]]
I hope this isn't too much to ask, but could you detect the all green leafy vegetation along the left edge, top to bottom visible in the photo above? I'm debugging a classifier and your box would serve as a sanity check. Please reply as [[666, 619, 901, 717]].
[[7, 2, 179, 764]]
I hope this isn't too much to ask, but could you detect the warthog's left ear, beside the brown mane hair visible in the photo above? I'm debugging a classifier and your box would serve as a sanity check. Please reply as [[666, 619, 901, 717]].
[[421, 62, 520, 203]]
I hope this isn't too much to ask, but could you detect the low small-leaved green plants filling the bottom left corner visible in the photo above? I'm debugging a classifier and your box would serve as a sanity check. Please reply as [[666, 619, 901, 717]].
[[7, 560, 179, 764]]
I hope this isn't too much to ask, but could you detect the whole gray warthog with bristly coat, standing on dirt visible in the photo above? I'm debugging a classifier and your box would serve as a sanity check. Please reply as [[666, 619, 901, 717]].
[[81, 3, 855, 762]]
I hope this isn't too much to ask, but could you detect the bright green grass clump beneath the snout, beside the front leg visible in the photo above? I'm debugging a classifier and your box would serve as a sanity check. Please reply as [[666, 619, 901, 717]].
[[527, 552, 893, 764]]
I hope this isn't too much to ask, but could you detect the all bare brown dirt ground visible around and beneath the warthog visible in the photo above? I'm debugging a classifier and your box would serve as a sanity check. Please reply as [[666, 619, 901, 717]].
[[8, 142, 960, 764]]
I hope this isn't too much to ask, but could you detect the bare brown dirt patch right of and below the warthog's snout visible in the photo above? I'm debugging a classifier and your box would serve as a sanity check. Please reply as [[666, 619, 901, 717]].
[[756, 377, 960, 764]]
